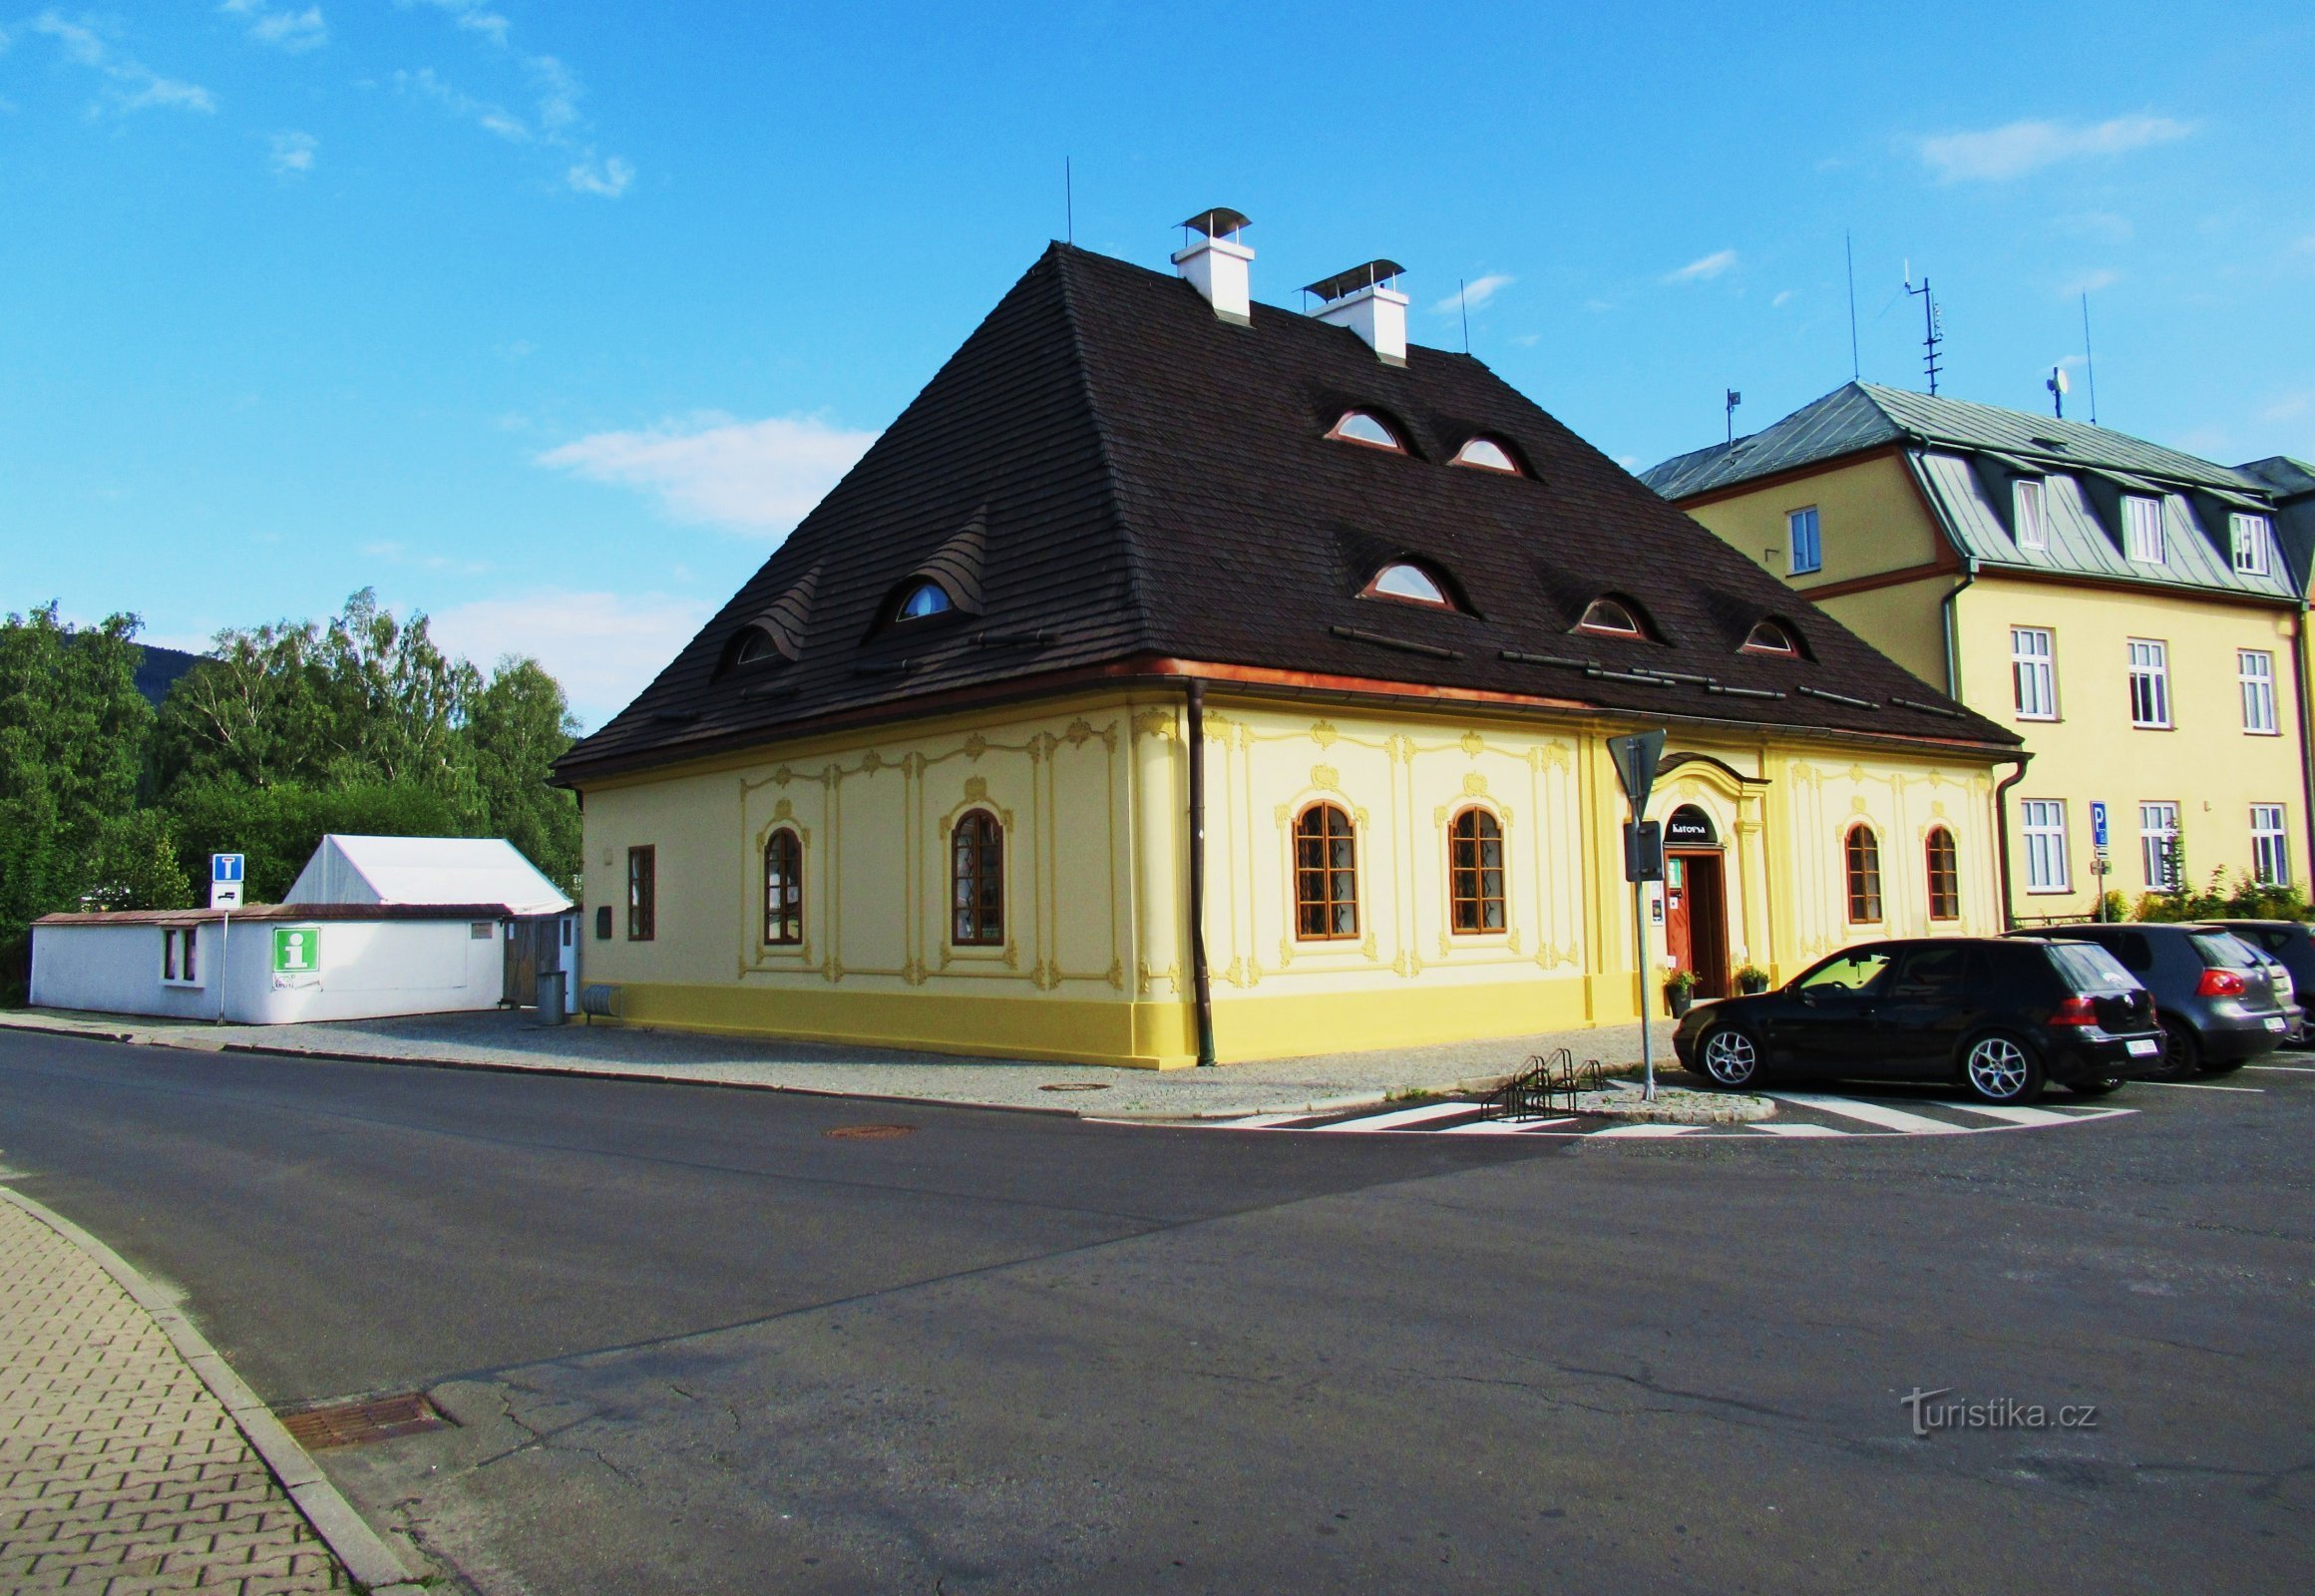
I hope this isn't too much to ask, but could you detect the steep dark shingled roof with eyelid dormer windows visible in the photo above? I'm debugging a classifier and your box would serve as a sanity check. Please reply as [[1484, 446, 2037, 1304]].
[[558, 243, 2017, 783]]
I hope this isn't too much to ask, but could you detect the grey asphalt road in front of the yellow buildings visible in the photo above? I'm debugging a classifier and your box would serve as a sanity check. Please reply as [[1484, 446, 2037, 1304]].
[[0, 1035, 2315, 1594]]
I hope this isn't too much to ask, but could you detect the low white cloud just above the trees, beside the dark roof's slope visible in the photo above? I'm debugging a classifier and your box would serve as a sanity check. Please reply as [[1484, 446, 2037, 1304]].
[[431, 589, 713, 725]]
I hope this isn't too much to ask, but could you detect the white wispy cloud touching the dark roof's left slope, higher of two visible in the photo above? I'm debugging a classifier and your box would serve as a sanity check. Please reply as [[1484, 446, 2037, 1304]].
[[537, 415, 875, 535]]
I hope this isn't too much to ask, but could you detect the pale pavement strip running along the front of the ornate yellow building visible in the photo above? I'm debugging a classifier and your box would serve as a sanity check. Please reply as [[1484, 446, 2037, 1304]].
[[0, 1009, 1676, 1121]]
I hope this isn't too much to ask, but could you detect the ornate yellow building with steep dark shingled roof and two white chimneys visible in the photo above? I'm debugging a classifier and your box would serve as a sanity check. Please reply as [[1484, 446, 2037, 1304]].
[[561, 224, 2019, 1068]]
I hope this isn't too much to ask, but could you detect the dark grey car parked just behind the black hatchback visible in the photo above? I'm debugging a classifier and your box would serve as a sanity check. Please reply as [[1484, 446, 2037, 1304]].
[[2026, 922, 2292, 1079]]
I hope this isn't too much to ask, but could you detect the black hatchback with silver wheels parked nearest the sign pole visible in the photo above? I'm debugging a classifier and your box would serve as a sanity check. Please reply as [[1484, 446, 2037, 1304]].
[[1672, 936, 2162, 1102]]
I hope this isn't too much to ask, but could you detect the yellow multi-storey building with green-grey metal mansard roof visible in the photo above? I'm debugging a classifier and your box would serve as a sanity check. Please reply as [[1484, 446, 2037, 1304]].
[[1644, 382, 2315, 925]]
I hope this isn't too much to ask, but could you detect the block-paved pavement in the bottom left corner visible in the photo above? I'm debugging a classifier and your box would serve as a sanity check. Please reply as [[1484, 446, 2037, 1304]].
[[0, 1202, 347, 1596]]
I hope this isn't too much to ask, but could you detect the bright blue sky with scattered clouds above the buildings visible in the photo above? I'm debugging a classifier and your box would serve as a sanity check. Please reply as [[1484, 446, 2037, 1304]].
[[0, 0, 2315, 723]]
